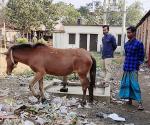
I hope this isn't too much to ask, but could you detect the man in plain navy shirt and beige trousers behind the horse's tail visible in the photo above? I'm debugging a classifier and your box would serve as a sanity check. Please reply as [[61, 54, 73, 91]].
[[102, 25, 117, 87]]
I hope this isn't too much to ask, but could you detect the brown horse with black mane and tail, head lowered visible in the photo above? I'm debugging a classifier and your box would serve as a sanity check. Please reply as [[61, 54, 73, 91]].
[[4, 43, 96, 104]]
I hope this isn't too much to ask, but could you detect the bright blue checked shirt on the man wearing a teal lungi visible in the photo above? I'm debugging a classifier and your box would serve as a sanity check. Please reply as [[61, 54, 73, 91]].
[[123, 38, 144, 71]]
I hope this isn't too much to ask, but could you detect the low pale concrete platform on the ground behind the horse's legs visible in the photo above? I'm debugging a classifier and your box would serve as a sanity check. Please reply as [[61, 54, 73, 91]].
[[46, 86, 110, 103]]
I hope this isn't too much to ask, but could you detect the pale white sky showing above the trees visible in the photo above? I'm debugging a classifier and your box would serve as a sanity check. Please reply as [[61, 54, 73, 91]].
[[54, 0, 150, 11]]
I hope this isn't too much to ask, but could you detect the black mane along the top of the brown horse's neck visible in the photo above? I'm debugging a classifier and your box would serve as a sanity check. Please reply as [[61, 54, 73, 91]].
[[10, 43, 47, 50]]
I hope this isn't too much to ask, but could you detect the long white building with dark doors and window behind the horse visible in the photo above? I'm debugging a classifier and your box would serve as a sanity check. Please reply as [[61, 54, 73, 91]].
[[53, 24, 122, 52]]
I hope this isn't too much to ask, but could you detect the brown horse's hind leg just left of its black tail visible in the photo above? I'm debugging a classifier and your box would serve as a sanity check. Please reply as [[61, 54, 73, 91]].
[[79, 75, 89, 106]]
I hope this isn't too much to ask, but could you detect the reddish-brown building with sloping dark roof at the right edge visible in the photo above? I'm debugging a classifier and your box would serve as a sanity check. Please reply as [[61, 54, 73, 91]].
[[136, 10, 150, 65]]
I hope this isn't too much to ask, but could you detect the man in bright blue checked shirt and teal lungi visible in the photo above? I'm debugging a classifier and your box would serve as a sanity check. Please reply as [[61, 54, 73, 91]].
[[119, 26, 144, 110]]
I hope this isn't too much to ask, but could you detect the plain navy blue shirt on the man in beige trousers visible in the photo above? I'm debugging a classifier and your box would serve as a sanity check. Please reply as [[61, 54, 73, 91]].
[[102, 34, 117, 59]]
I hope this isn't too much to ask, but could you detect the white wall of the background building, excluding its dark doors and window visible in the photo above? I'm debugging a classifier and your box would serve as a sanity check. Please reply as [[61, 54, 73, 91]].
[[53, 26, 122, 51]]
